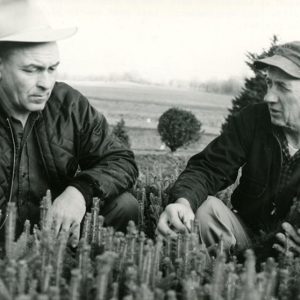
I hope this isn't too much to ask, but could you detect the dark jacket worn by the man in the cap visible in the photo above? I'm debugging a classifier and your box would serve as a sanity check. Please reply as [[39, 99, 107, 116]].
[[171, 103, 292, 228]]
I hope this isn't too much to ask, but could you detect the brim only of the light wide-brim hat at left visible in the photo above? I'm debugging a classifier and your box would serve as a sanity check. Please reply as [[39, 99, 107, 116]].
[[0, 27, 77, 43]]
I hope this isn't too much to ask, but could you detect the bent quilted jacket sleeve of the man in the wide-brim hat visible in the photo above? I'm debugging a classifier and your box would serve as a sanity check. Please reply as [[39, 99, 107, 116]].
[[71, 95, 138, 204]]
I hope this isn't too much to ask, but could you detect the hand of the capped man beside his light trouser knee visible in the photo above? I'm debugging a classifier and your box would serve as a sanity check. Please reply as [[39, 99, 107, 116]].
[[157, 198, 195, 237]]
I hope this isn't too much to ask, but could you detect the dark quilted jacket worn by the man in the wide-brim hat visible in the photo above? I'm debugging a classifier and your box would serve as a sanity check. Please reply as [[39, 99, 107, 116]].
[[0, 83, 138, 217]]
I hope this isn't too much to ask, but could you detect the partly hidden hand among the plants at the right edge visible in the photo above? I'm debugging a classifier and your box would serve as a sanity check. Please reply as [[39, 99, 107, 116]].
[[273, 222, 300, 255]]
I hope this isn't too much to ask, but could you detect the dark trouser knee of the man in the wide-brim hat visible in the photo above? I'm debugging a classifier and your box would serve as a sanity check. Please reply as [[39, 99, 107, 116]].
[[100, 192, 139, 233]]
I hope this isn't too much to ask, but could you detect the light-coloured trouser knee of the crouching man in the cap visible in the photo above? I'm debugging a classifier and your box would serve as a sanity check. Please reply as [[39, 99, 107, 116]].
[[196, 196, 251, 250]]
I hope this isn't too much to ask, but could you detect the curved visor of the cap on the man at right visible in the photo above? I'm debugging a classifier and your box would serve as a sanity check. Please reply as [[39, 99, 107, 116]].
[[254, 54, 300, 79]]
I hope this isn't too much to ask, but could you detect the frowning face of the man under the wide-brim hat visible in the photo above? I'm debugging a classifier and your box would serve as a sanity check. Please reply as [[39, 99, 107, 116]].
[[0, 43, 59, 115]]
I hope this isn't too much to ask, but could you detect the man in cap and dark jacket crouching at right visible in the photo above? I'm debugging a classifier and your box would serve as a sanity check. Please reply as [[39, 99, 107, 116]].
[[158, 42, 300, 254]]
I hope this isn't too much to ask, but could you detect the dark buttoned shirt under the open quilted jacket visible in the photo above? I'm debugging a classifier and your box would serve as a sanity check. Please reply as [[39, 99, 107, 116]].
[[11, 113, 50, 232]]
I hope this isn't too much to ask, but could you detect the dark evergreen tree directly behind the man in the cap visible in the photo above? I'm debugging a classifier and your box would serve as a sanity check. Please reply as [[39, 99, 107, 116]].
[[222, 35, 278, 131]]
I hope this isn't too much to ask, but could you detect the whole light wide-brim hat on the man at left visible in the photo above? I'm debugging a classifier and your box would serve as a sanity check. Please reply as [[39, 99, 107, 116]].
[[0, 0, 77, 43]]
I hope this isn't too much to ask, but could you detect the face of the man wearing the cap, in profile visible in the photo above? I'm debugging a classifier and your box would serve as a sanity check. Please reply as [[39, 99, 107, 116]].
[[264, 68, 300, 131]]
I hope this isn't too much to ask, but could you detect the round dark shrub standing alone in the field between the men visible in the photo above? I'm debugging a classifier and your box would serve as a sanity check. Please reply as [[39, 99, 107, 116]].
[[157, 107, 202, 152]]
